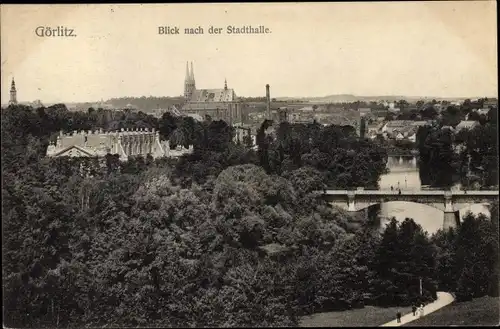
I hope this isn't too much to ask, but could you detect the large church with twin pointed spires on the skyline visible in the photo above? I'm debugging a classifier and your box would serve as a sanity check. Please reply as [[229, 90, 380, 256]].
[[181, 62, 244, 124]]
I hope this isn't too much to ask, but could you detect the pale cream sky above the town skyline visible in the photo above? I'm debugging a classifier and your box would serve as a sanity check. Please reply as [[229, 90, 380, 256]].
[[0, 1, 498, 103]]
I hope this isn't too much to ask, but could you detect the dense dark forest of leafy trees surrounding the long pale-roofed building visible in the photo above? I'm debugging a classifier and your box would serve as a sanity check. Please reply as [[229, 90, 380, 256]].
[[2, 104, 498, 328]]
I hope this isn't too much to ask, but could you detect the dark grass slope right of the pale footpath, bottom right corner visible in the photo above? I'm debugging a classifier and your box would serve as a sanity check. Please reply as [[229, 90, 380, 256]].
[[403, 297, 500, 327]]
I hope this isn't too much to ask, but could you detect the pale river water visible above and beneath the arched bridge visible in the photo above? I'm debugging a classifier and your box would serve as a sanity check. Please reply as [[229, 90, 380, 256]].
[[379, 161, 490, 234]]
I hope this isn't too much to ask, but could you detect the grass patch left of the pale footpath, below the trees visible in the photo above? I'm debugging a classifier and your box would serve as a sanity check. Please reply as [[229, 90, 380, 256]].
[[299, 306, 411, 327]]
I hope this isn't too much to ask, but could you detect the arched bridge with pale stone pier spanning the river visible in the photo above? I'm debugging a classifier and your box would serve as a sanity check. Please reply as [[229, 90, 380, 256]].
[[320, 190, 498, 229]]
